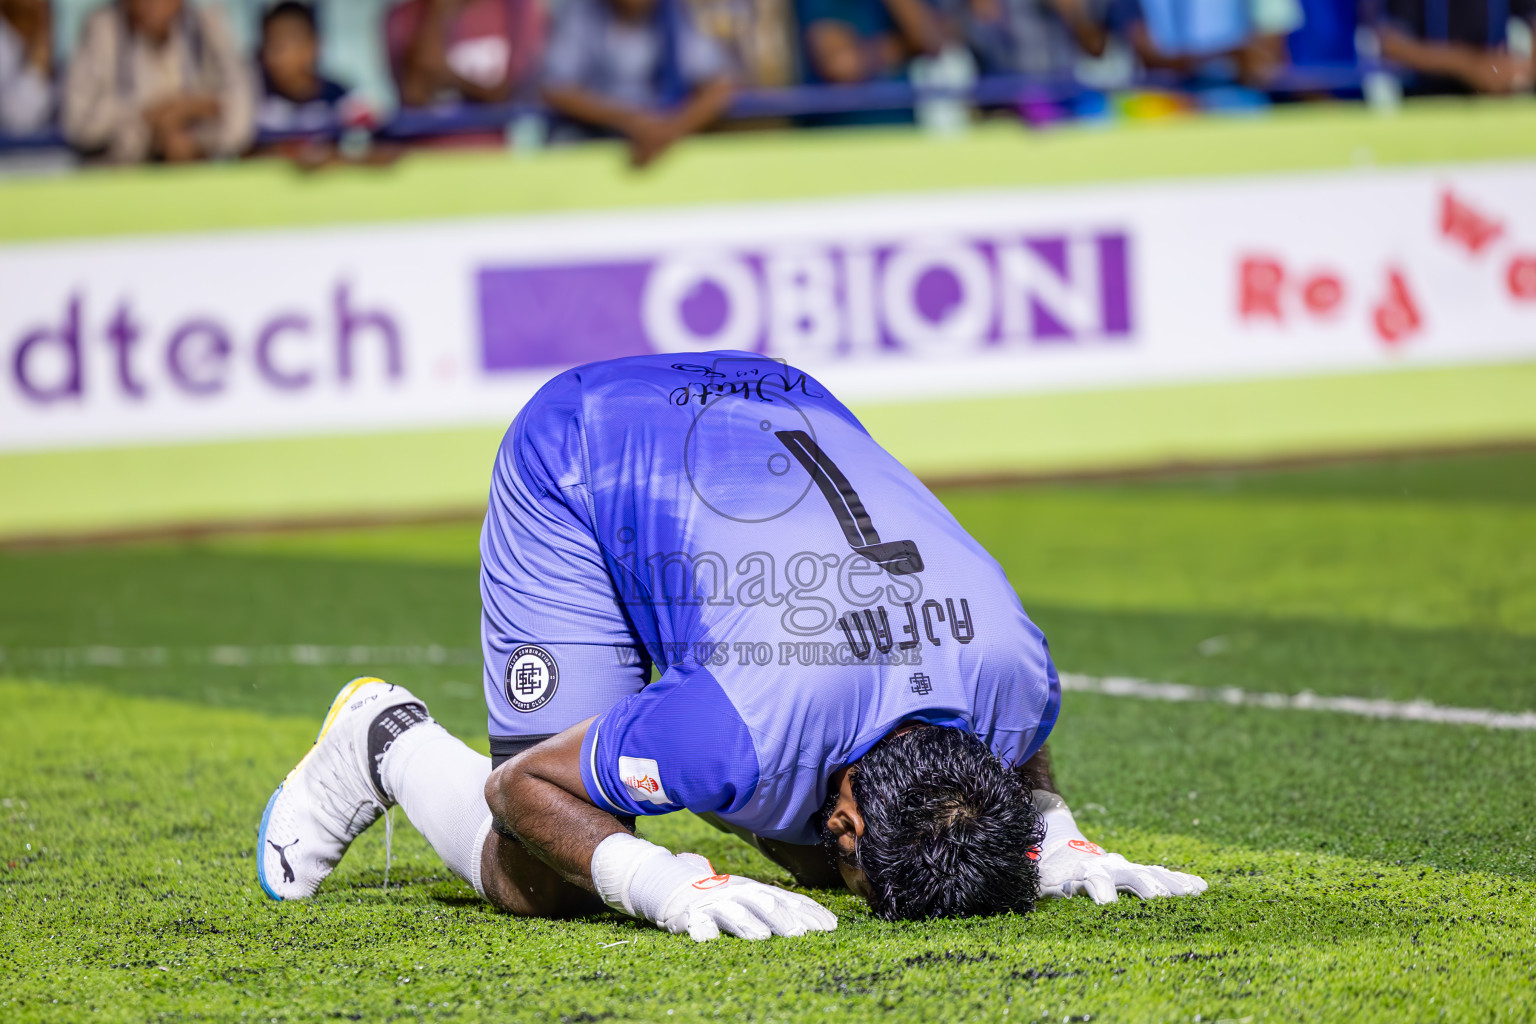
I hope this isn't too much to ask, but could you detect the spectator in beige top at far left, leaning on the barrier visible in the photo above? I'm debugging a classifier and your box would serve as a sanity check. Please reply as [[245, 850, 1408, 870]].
[[63, 0, 255, 163]]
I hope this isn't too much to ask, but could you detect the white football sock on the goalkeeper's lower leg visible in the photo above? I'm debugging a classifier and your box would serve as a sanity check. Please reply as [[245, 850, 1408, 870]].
[[379, 722, 492, 897]]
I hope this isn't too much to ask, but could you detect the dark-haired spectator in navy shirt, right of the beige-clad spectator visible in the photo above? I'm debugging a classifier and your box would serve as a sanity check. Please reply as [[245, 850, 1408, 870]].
[[257, 0, 364, 132]]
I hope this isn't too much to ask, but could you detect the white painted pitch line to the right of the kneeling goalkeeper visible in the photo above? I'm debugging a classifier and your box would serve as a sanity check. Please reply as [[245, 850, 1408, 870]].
[[1061, 672, 1536, 732]]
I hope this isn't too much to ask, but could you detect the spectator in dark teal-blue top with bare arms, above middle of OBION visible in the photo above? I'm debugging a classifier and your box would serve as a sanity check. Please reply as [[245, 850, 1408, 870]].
[[799, 0, 945, 84]]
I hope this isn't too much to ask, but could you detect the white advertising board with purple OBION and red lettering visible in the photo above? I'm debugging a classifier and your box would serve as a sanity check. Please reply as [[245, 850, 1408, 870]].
[[0, 161, 1536, 451]]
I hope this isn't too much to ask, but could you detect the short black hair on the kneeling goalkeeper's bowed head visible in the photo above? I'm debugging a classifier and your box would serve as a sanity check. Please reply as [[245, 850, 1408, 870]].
[[822, 726, 1044, 921]]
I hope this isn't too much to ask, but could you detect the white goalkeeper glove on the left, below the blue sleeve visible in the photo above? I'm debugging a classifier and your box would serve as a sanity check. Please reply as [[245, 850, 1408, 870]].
[[591, 832, 837, 943]]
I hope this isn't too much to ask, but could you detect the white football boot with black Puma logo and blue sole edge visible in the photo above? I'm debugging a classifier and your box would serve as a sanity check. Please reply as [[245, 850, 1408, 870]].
[[257, 676, 422, 900]]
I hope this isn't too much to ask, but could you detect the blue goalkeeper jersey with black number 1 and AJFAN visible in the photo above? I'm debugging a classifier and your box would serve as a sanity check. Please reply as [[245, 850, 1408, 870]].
[[504, 352, 1060, 843]]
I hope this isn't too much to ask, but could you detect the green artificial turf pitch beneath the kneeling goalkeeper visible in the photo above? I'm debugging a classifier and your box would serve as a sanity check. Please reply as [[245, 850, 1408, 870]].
[[0, 453, 1536, 1022]]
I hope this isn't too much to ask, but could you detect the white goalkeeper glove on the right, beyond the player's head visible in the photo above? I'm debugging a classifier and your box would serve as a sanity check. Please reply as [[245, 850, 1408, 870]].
[[1035, 789, 1206, 903]]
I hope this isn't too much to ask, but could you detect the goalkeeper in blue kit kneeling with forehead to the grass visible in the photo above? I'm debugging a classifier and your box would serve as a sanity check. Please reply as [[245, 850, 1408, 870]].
[[258, 352, 1206, 941]]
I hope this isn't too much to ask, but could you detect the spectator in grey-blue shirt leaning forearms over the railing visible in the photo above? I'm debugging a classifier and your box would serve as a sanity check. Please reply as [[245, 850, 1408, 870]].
[[544, 0, 733, 167]]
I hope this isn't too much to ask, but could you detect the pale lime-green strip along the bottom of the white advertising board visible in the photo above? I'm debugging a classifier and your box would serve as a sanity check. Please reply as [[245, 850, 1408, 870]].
[[9, 360, 1536, 540]]
